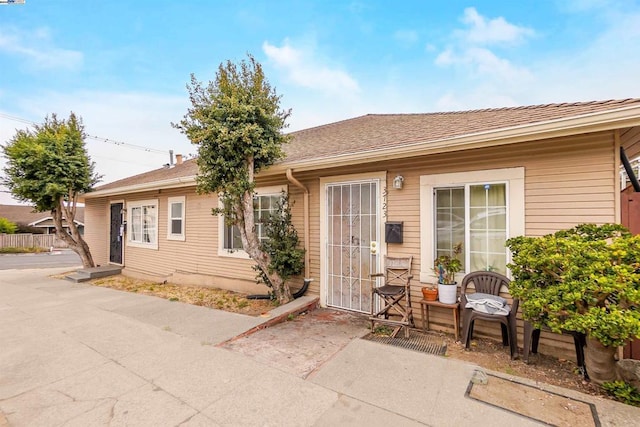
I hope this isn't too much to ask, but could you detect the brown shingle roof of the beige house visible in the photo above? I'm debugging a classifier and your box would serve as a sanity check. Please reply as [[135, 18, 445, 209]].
[[89, 98, 640, 191]]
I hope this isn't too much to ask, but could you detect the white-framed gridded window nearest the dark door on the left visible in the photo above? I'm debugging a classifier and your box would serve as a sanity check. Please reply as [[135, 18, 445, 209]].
[[127, 200, 158, 249]]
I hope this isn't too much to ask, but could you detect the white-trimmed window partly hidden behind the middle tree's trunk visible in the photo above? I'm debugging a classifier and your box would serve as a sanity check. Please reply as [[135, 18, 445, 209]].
[[219, 186, 286, 258]]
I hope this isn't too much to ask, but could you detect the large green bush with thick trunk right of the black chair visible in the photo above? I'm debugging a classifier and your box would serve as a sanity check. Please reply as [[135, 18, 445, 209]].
[[507, 224, 640, 384]]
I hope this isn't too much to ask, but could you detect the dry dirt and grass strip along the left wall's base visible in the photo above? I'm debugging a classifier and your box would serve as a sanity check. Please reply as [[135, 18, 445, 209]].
[[87, 275, 275, 316]]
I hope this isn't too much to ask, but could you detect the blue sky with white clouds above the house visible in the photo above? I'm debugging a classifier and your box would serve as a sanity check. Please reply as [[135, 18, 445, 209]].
[[0, 0, 640, 203]]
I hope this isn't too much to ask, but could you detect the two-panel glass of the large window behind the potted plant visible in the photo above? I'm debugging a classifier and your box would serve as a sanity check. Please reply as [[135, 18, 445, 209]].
[[433, 182, 508, 274]]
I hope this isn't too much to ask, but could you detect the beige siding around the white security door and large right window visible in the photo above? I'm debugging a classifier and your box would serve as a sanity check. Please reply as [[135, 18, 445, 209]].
[[301, 132, 617, 353]]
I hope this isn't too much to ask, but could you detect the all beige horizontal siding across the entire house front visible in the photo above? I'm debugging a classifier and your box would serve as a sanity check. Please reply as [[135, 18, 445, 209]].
[[85, 128, 620, 355]]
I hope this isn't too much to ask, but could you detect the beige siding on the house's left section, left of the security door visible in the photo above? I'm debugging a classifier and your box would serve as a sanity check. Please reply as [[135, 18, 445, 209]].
[[86, 180, 304, 293]]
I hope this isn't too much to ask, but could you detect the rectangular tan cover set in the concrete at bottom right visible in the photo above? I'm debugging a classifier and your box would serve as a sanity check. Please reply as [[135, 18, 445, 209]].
[[465, 370, 600, 427]]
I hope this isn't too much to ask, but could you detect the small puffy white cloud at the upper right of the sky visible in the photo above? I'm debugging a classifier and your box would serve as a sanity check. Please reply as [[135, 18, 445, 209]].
[[458, 7, 535, 45]]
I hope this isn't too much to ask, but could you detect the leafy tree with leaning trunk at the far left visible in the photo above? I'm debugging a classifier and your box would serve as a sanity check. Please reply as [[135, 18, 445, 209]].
[[2, 113, 100, 267]]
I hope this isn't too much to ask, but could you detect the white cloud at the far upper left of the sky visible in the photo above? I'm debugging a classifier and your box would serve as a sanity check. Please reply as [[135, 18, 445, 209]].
[[0, 28, 84, 70]]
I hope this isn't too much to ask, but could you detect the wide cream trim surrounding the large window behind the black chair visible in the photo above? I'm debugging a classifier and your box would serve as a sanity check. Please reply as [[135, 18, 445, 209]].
[[420, 167, 525, 283]]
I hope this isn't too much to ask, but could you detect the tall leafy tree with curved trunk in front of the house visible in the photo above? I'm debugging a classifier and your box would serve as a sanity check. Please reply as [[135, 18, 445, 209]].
[[173, 55, 292, 304]]
